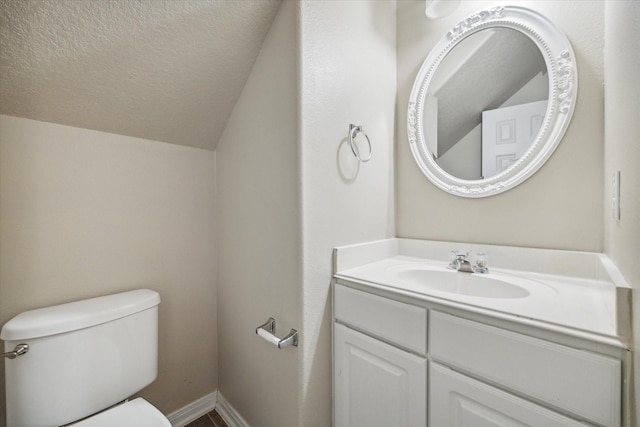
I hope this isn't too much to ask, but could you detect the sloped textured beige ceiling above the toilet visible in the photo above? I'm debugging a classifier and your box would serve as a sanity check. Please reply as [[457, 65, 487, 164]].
[[0, 0, 279, 149]]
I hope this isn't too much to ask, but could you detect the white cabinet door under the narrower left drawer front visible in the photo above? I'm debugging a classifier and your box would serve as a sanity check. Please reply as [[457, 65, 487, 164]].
[[334, 324, 427, 427]]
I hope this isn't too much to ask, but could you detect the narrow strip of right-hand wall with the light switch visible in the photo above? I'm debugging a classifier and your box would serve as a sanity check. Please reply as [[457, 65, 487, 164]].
[[604, 1, 640, 425]]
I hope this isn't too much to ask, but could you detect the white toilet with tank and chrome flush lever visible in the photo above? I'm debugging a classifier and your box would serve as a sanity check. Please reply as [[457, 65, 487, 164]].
[[0, 289, 171, 427]]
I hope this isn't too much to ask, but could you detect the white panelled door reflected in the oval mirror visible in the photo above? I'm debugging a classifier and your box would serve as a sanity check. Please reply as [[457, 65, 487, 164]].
[[482, 101, 547, 178]]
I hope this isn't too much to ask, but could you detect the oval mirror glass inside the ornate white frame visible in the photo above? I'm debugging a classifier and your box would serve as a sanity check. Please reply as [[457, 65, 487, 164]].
[[422, 28, 549, 180]]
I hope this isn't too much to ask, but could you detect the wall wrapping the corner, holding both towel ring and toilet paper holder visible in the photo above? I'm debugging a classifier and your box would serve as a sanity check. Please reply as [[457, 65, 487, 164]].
[[217, 0, 395, 427]]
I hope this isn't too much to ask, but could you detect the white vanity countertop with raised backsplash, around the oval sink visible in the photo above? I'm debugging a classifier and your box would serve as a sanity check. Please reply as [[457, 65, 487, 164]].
[[334, 239, 630, 347]]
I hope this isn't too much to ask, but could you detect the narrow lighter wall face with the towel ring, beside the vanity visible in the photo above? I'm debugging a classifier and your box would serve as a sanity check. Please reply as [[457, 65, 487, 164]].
[[298, 0, 396, 427]]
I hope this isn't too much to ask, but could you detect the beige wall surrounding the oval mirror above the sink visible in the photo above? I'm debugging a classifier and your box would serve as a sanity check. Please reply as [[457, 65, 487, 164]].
[[396, 0, 604, 251]]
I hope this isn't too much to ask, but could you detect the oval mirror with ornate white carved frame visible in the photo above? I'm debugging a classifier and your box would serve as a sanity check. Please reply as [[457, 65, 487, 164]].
[[407, 6, 577, 197]]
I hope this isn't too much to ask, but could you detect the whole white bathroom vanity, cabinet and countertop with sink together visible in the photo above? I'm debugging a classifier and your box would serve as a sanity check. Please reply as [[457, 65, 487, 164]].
[[333, 239, 631, 427]]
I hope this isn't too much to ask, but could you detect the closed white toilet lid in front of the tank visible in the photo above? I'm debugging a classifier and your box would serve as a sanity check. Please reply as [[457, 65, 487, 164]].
[[73, 397, 171, 427]]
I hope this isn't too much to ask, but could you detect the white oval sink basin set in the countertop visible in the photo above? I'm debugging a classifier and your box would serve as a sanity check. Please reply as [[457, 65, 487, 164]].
[[395, 268, 530, 298]]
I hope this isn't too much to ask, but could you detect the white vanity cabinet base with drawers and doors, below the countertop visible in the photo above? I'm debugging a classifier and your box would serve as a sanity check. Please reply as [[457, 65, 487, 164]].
[[334, 283, 622, 427]]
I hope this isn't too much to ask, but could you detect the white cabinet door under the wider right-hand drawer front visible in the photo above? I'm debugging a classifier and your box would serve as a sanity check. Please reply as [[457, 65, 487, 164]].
[[429, 362, 588, 427]]
